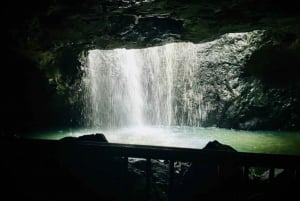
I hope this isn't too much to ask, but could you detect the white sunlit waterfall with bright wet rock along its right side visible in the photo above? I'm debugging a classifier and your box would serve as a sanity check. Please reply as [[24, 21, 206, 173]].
[[83, 31, 263, 128]]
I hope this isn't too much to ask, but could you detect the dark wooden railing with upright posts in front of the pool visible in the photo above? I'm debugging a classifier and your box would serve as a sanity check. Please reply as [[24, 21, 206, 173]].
[[2, 140, 300, 200]]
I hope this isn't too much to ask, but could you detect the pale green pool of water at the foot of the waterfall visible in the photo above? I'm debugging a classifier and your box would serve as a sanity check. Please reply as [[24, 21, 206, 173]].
[[29, 126, 300, 155]]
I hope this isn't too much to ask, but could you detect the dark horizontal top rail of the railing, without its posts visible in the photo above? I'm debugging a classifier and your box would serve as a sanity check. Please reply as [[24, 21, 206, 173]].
[[1, 139, 300, 168]]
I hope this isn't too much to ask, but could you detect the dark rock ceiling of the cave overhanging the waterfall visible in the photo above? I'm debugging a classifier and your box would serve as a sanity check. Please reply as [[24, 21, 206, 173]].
[[4, 0, 300, 51]]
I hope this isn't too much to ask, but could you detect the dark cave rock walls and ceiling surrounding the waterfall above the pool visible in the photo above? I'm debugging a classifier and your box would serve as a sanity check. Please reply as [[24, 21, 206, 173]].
[[1, 0, 300, 135]]
